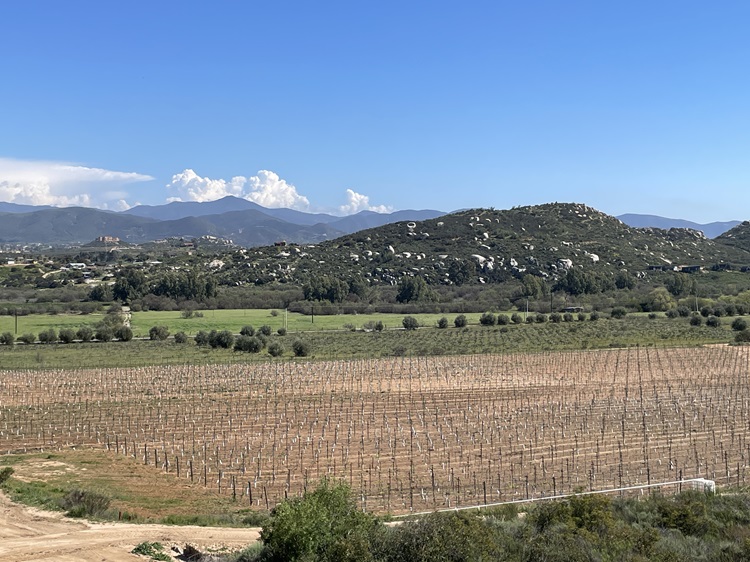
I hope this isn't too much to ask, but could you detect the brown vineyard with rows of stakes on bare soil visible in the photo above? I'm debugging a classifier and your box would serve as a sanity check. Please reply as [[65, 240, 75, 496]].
[[0, 345, 750, 513]]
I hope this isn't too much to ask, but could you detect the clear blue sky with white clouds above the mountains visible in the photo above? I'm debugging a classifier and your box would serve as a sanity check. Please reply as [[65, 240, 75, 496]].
[[0, 0, 750, 222]]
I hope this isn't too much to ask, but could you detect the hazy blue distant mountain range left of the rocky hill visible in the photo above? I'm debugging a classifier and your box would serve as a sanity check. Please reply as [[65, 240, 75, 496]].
[[0, 196, 444, 246]]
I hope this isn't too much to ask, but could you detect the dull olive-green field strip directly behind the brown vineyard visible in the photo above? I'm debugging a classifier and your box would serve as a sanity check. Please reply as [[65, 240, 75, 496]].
[[0, 313, 734, 369]]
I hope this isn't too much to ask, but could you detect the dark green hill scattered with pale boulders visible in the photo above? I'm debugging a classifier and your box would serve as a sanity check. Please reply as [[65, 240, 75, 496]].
[[225, 203, 750, 284]]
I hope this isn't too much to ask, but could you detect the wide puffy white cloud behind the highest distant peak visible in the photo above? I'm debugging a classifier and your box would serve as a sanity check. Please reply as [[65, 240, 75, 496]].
[[167, 169, 310, 211]]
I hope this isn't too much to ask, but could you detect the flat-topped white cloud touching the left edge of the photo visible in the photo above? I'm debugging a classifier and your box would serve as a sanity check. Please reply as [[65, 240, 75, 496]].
[[0, 158, 154, 210]]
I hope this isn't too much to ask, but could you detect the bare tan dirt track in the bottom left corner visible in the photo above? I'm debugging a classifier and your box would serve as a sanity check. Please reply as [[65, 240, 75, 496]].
[[0, 493, 260, 562]]
